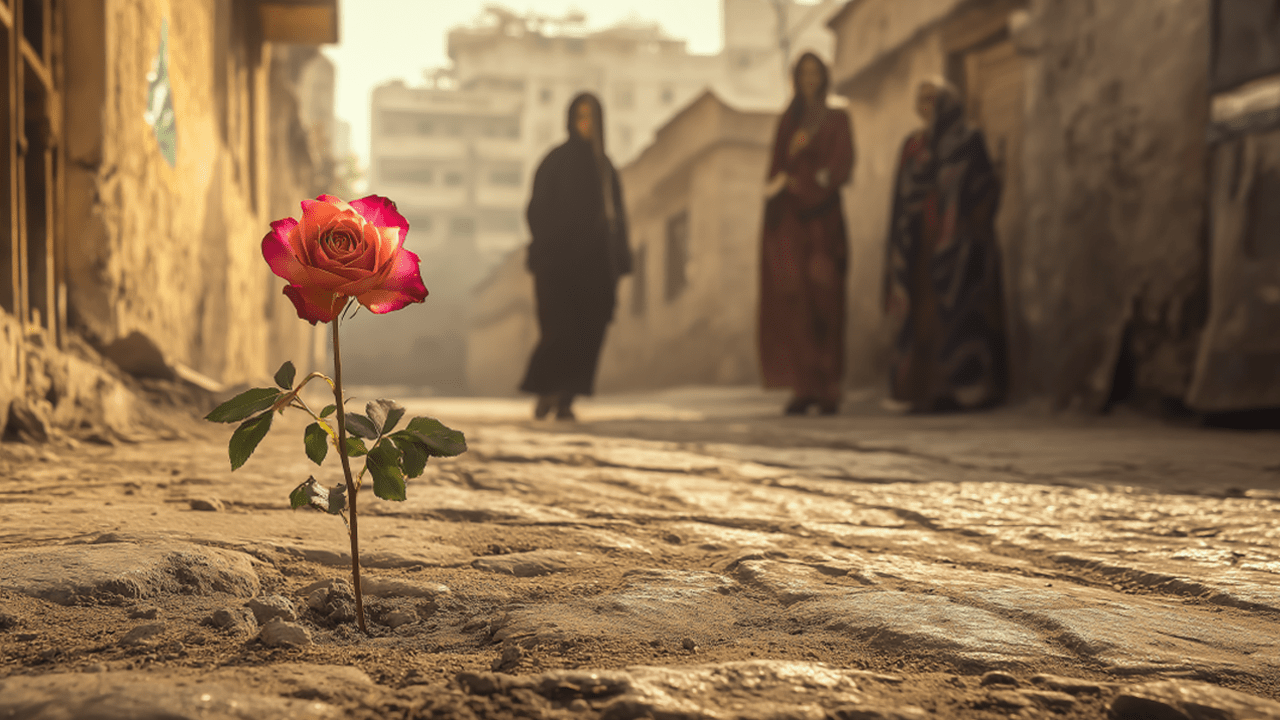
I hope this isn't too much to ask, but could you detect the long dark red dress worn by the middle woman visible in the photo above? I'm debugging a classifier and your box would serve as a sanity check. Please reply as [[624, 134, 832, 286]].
[[759, 109, 854, 404]]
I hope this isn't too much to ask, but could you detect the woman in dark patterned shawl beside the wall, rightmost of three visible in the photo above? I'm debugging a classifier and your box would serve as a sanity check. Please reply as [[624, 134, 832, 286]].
[[883, 81, 1007, 413]]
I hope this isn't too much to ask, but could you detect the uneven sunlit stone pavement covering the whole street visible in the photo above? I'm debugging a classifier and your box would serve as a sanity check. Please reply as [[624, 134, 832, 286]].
[[0, 388, 1280, 719]]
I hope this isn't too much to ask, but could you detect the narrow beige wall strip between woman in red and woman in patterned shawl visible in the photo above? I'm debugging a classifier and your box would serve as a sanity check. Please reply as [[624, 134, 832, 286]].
[[837, 33, 945, 387]]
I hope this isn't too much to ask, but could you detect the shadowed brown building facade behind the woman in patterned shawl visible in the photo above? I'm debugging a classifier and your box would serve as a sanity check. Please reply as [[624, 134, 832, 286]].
[[829, 0, 1280, 411]]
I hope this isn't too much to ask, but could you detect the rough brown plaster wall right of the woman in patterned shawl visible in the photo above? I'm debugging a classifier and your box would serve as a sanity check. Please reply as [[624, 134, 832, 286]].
[[1006, 0, 1210, 409]]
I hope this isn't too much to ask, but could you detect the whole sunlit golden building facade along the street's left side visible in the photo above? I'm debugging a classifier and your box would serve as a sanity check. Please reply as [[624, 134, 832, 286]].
[[0, 0, 337, 434]]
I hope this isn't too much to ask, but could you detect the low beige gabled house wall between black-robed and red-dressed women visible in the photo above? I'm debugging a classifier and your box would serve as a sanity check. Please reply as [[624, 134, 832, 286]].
[[599, 137, 768, 392]]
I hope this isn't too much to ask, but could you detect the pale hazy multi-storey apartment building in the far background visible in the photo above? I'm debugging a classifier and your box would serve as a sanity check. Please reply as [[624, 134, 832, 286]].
[[370, 0, 840, 386]]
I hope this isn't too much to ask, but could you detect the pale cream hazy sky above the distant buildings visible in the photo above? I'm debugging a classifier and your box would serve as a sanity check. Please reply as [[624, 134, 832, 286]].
[[325, 0, 723, 164]]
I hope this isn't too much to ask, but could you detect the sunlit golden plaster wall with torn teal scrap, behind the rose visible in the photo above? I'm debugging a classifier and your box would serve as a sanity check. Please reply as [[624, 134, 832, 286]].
[[65, 0, 322, 383]]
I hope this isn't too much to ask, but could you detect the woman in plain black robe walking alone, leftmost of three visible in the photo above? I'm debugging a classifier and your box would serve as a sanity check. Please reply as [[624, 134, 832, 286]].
[[520, 92, 631, 420]]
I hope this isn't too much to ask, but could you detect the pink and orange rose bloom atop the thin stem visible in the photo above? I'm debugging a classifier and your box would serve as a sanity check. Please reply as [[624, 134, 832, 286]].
[[262, 195, 426, 325]]
